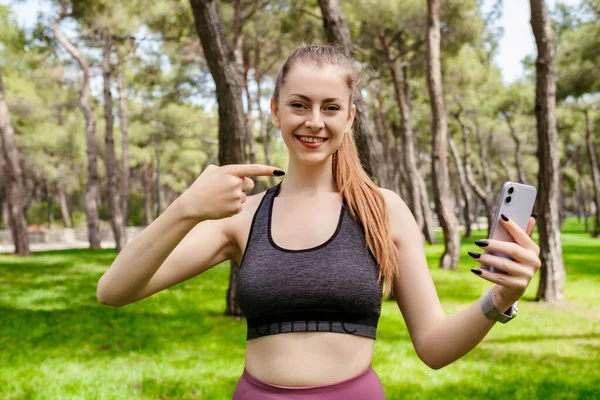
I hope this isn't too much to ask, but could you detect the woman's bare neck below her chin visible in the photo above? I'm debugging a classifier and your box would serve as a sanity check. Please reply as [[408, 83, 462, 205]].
[[279, 157, 337, 196]]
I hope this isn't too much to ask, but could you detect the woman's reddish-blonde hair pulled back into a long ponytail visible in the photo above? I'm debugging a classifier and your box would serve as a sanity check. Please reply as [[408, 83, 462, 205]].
[[273, 44, 397, 296]]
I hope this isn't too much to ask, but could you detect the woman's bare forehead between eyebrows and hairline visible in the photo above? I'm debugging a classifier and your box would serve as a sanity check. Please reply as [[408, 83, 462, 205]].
[[280, 62, 350, 100]]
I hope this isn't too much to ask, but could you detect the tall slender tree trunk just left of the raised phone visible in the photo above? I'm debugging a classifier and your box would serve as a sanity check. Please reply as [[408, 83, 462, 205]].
[[427, 0, 460, 269]]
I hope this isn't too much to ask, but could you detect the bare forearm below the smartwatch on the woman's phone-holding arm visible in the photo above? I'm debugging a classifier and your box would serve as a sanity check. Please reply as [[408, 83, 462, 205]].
[[419, 290, 510, 369]]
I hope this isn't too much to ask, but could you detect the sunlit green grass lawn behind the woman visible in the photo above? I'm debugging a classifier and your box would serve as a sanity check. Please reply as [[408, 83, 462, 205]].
[[0, 220, 600, 399]]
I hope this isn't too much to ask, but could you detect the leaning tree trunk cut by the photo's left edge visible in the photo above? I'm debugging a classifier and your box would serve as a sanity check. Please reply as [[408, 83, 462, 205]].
[[0, 70, 31, 256]]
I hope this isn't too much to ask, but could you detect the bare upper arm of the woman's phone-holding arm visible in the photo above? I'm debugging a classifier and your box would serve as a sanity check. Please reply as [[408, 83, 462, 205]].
[[381, 189, 444, 353]]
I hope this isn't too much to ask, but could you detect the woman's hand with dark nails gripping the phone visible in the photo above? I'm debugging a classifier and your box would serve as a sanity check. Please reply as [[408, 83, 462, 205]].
[[469, 217, 541, 309]]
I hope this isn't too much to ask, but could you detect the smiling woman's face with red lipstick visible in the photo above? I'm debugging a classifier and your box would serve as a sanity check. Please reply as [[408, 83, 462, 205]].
[[271, 62, 356, 164]]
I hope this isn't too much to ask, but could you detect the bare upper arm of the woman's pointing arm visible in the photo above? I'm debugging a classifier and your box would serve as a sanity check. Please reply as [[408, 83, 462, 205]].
[[133, 219, 233, 301]]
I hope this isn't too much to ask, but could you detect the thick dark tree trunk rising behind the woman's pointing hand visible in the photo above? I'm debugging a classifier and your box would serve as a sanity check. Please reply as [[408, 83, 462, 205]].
[[190, 0, 247, 316]]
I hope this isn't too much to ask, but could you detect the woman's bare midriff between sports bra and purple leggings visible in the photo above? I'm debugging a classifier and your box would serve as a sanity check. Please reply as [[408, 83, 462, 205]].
[[245, 332, 375, 386]]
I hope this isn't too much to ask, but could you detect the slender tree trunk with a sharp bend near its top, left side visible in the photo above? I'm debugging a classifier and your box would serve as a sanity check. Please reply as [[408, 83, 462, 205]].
[[53, 1, 100, 249]]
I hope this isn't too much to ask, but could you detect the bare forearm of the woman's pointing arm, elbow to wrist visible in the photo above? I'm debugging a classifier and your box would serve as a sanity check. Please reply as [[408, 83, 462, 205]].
[[97, 200, 201, 306]]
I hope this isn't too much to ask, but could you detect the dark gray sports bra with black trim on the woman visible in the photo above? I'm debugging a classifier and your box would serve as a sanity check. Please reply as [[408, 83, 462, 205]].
[[236, 183, 382, 339]]
